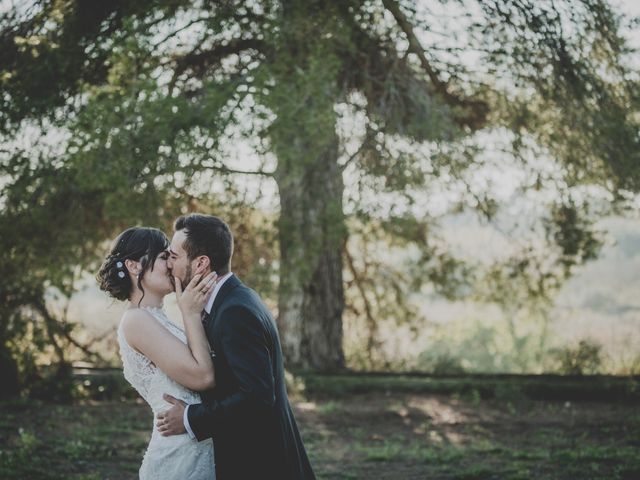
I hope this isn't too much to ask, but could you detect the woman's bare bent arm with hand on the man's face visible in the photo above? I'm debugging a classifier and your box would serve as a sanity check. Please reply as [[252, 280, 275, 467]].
[[122, 274, 215, 390]]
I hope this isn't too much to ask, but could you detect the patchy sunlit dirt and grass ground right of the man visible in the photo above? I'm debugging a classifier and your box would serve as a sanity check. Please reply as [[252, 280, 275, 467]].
[[297, 394, 640, 479]]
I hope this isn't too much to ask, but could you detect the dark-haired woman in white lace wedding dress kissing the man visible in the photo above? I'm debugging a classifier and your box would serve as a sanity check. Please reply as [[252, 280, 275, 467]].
[[97, 227, 216, 480]]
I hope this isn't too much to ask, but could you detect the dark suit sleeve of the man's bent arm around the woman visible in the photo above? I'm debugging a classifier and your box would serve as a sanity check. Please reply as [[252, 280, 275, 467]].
[[188, 307, 275, 441]]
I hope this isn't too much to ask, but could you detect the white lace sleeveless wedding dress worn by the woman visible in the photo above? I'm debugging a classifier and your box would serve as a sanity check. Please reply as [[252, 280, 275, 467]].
[[118, 308, 215, 480]]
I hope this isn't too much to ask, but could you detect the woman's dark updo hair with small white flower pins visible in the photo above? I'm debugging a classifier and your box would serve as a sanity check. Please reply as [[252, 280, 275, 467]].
[[96, 227, 169, 300]]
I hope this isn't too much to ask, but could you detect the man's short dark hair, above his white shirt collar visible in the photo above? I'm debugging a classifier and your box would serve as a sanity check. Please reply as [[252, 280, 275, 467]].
[[174, 213, 233, 275]]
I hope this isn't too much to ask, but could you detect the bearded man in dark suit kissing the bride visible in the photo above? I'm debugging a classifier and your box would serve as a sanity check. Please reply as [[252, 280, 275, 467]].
[[157, 214, 315, 480]]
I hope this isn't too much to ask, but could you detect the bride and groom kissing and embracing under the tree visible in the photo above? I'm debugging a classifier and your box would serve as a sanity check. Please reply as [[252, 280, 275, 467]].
[[97, 214, 315, 480]]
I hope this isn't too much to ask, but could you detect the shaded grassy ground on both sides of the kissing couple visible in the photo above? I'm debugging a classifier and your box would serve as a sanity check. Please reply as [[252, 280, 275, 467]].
[[0, 376, 640, 480]]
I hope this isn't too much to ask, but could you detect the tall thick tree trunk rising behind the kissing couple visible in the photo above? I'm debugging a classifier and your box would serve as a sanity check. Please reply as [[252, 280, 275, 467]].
[[265, 0, 346, 371]]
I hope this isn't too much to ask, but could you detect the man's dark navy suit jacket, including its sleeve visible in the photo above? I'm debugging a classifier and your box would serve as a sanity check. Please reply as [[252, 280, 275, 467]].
[[188, 275, 315, 480]]
